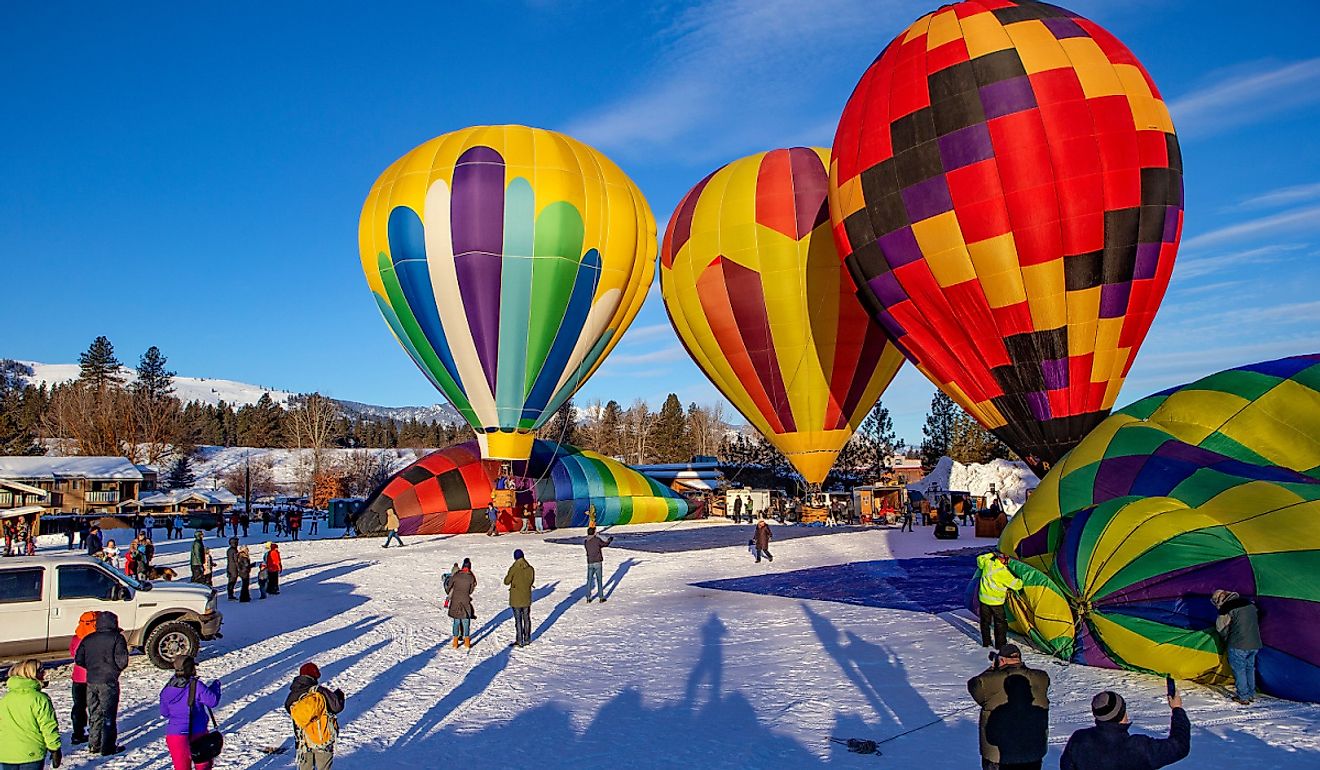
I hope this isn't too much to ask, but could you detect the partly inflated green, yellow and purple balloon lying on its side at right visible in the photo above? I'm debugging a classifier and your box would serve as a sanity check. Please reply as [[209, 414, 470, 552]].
[[999, 355, 1320, 701]]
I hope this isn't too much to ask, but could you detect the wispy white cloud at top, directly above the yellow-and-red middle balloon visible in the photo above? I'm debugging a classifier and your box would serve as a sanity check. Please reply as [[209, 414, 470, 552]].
[[566, 0, 923, 162]]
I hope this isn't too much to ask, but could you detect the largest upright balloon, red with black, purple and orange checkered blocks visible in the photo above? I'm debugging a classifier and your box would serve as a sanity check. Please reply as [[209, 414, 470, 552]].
[[830, 0, 1183, 474]]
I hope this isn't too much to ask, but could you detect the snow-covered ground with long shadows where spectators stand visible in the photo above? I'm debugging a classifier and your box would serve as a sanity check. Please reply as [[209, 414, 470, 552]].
[[28, 522, 1320, 770]]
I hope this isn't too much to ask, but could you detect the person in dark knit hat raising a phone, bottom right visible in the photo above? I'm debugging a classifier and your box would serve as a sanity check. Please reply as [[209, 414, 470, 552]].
[[1059, 689, 1192, 770]]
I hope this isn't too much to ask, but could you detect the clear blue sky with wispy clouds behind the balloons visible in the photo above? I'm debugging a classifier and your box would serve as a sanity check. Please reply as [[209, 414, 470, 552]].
[[0, 0, 1320, 440]]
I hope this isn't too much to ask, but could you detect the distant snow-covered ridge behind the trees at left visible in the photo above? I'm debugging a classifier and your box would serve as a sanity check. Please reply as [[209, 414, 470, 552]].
[[18, 361, 463, 424]]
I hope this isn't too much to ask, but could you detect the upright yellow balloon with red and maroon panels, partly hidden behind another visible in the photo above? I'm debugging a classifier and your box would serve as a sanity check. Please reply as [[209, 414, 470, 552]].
[[660, 147, 903, 485]]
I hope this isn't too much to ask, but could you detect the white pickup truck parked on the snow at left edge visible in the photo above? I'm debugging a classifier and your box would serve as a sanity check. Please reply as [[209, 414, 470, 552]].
[[0, 556, 220, 668]]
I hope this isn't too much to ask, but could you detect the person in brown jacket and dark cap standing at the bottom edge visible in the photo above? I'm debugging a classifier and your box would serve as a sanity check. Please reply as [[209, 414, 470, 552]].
[[968, 643, 1049, 770]]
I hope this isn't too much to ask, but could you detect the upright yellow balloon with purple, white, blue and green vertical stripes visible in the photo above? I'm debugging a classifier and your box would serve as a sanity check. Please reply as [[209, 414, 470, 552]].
[[358, 125, 656, 460]]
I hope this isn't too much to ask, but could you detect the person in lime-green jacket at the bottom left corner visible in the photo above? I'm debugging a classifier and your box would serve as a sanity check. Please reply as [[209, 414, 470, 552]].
[[0, 660, 63, 770]]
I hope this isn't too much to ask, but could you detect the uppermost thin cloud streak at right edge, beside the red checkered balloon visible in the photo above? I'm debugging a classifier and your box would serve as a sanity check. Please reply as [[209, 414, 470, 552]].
[[1168, 57, 1320, 136]]
